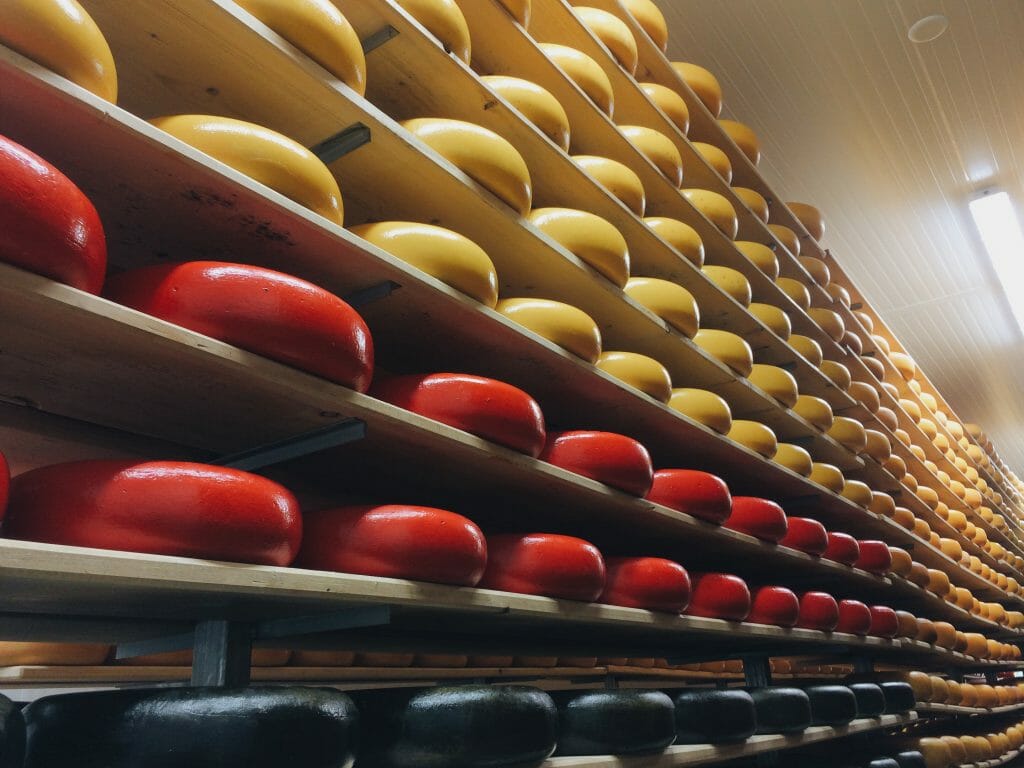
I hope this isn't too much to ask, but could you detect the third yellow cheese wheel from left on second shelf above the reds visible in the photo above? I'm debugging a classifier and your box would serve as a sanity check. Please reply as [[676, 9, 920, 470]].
[[526, 208, 630, 288]]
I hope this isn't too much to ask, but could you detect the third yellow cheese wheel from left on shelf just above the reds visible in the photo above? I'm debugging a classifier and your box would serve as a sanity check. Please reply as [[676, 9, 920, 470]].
[[350, 221, 498, 307]]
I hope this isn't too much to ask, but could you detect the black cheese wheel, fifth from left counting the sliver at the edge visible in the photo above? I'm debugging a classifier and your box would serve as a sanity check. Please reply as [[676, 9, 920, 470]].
[[675, 688, 757, 744]]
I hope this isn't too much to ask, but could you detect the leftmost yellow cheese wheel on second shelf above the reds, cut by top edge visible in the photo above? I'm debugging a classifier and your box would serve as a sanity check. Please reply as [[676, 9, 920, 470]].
[[239, 0, 366, 96]]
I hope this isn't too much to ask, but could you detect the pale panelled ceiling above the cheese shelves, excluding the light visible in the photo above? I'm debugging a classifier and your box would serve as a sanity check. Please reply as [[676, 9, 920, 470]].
[[657, 0, 1024, 475]]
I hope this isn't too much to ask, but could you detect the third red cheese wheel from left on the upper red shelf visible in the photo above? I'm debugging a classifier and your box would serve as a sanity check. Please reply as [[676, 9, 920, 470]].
[[371, 374, 545, 457]]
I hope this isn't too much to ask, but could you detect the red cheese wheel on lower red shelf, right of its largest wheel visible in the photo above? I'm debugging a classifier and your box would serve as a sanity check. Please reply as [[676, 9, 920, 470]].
[[295, 504, 487, 587]]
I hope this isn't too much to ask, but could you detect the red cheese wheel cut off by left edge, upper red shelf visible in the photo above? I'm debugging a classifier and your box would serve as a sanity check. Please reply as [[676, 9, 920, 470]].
[[0, 136, 106, 293]]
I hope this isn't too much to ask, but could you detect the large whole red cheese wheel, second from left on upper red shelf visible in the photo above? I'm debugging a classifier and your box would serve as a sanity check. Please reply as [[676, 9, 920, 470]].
[[104, 261, 374, 392]]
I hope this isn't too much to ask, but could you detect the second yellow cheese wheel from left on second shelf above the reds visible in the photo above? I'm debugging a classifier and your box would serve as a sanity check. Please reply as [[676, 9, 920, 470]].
[[401, 118, 532, 216]]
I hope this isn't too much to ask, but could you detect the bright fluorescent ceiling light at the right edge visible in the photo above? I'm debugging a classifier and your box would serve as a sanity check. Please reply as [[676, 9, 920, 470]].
[[970, 191, 1024, 331]]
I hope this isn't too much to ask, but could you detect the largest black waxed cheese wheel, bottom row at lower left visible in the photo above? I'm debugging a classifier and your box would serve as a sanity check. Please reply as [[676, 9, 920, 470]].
[[24, 686, 362, 768]]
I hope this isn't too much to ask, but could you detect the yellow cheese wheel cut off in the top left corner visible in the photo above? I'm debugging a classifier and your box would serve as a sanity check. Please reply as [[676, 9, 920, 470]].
[[0, 0, 117, 103]]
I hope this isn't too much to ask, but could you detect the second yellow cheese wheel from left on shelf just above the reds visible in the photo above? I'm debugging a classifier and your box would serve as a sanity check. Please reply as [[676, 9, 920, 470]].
[[150, 115, 344, 224]]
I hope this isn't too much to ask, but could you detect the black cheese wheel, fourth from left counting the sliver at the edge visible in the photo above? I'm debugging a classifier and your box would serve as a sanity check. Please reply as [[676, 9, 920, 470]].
[[553, 689, 676, 757]]
